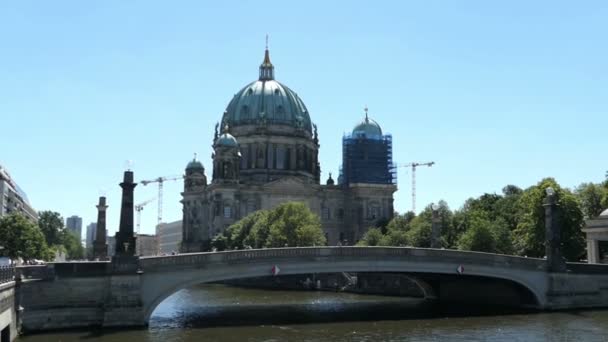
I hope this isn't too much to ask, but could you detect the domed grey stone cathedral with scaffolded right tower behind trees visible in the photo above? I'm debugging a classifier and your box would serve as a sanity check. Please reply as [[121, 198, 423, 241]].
[[181, 48, 397, 252]]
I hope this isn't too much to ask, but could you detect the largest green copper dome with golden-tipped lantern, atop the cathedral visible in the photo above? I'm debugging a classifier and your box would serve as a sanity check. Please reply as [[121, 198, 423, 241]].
[[222, 49, 312, 133]]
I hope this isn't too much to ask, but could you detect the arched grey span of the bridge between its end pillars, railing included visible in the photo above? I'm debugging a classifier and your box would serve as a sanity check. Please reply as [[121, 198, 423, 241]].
[[140, 247, 546, 324]]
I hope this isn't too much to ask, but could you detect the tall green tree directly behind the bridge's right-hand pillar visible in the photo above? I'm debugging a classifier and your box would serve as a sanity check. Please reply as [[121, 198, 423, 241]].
[[513, 178, 585, 261]]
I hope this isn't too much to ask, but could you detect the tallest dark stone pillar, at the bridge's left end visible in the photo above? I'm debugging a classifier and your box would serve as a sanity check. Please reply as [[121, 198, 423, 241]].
[[116, 171, 137, 256]]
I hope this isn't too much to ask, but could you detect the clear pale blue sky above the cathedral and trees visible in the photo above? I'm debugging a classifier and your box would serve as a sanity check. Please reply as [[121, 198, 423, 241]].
[[0, 0, 608, 239]]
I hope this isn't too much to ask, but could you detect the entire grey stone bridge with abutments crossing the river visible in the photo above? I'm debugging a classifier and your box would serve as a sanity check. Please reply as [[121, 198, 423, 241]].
[[16, 247, 608, 330]]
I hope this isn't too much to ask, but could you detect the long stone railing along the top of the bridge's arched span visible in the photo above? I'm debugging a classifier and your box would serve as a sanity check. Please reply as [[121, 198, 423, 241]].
[[139, 247, 546, 271]]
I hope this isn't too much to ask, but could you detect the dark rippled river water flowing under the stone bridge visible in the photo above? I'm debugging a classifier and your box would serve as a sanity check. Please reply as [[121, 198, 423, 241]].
[[19, 285, 608, 342]]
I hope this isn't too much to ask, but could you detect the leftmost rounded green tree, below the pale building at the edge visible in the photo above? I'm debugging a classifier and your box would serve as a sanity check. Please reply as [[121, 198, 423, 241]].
[[0, 214, 52, 260]]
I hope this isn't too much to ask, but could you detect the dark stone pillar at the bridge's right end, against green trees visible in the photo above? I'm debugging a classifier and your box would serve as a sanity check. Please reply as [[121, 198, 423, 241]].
[[543, 188, 566, 272]]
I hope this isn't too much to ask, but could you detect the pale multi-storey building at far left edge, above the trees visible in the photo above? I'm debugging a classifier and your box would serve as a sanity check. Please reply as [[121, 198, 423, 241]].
[[0, 165, 38, 221]]
